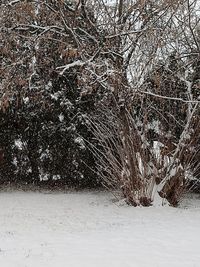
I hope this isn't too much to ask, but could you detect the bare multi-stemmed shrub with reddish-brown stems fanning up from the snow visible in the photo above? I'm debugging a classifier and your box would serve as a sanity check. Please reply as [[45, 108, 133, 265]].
[[90, 94, 199, 206]]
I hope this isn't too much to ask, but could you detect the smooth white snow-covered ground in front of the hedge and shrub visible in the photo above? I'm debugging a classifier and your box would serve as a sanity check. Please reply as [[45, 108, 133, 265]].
[[0, 192, 200, 267]]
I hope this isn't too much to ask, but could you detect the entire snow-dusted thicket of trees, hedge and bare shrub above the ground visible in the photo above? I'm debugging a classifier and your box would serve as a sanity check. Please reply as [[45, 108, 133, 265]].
[[0, 0, 200, 206]]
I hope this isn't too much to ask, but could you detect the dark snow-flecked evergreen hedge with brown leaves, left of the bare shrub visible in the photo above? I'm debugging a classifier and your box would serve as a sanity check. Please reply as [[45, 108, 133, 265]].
[[0, 1, 99, 187]]
